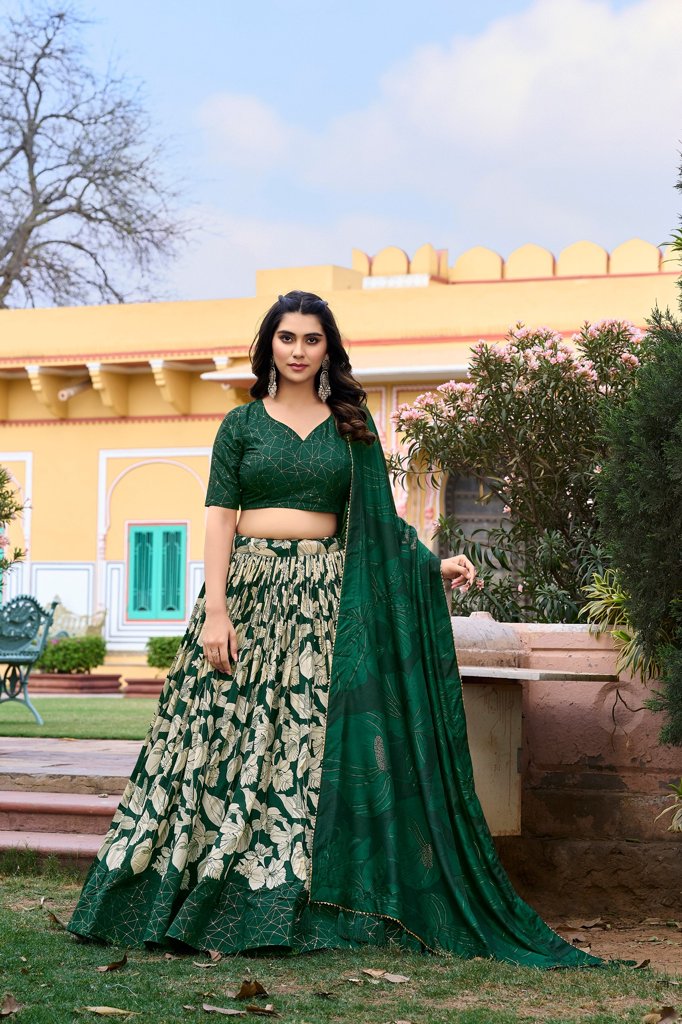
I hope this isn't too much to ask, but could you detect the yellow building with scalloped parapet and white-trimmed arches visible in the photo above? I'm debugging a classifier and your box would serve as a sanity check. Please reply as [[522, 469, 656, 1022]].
[[0, 240, 679, 651]]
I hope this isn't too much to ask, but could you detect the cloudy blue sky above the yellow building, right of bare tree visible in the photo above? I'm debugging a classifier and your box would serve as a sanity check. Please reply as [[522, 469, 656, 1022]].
[[15, 0, 682, 298]]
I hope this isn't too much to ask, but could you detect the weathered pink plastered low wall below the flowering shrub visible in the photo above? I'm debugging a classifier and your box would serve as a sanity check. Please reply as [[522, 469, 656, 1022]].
[[499, 625, 682, 916]]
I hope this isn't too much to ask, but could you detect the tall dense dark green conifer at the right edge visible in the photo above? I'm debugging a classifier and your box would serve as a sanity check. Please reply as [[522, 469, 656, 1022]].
[[598, 309, 682, 745]]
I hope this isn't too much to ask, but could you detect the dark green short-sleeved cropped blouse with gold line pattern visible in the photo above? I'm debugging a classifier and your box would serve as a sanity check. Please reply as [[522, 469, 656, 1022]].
[[206, 399, 351, 515]]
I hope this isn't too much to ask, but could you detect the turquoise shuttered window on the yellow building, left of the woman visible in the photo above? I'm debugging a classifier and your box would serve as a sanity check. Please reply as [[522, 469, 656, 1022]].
[[128, 525, 187, 620]]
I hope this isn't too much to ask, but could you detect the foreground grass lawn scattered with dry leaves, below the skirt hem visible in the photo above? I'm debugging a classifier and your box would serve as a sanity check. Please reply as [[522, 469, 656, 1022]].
[[0, 857, 680, 1024]]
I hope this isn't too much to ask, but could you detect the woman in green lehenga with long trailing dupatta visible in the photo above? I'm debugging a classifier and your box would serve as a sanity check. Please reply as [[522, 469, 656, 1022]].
[[69, 292, 598, 966]]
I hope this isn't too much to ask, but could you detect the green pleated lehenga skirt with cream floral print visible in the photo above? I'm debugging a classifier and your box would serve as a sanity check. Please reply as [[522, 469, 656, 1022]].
[[69, 536, 409, 953]]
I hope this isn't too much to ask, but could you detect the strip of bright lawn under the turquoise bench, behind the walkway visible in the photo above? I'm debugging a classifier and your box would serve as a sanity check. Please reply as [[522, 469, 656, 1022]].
[[0, 696, 157, 740]]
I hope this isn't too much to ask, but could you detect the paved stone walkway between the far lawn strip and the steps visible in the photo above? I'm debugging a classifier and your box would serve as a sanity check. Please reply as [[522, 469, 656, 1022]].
[[0, 736, 141, 793]]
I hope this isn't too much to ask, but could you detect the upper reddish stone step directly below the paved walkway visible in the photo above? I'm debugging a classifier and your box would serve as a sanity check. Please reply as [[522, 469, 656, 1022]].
[[0, 790, 120, 836]]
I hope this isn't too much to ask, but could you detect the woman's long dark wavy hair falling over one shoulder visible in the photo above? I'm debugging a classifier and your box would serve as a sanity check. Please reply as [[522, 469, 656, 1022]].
[[249, 292, 377, 444]]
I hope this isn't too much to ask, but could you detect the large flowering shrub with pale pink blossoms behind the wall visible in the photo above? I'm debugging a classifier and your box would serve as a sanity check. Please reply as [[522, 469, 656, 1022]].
[[389, 319, 647, 623]]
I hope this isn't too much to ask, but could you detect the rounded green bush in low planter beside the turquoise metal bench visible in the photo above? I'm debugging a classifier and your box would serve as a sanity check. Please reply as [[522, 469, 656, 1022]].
[[29, 636, 121, 693]]
